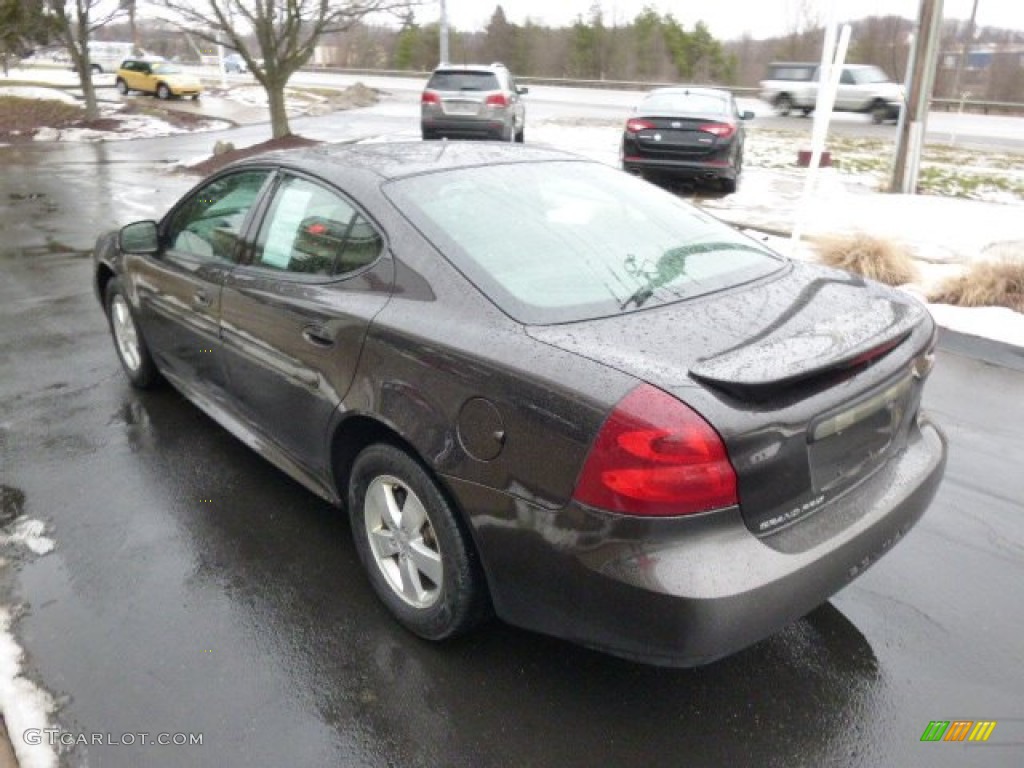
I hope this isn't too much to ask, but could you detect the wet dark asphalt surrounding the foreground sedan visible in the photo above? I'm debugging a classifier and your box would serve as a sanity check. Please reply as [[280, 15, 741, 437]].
[[0, 134, 1024, 768]]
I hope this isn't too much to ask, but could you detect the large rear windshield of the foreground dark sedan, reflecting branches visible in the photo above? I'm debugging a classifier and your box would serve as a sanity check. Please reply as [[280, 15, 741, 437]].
[[386, 161, 783, 324]]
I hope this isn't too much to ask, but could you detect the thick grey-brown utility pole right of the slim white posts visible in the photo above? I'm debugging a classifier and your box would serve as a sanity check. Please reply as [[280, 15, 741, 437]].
[[889, 0, 942, 195]]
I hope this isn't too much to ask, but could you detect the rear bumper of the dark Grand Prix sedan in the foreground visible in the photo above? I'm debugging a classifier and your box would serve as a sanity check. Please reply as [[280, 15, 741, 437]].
[[453, 415, 946, 667]]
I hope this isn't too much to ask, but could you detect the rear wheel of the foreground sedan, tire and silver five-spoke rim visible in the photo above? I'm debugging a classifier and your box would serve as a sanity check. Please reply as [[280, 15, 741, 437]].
[[348, 443, 489, 640]]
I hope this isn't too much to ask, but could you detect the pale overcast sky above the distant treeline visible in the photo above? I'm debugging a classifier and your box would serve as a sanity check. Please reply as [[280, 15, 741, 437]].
[[436, 0, 1024, 40]]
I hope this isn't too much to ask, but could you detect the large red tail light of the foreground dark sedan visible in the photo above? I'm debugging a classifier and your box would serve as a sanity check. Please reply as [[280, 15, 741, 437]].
[[572, 384, 738, 516]]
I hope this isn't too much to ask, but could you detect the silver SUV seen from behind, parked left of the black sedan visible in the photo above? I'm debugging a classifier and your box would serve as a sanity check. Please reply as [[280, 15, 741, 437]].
[[420, 63, 528, 142]]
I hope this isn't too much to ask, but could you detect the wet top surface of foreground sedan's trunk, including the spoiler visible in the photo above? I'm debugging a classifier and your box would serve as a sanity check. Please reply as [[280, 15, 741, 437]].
[[527, 263, 929, 399]]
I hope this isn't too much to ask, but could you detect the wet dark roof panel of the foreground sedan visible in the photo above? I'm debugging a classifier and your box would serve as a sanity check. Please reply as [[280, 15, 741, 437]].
[[231, 141, 594, 180]]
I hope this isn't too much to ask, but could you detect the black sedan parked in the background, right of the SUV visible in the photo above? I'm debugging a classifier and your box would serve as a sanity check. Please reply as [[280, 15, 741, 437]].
[[622, 87, 754, 193]]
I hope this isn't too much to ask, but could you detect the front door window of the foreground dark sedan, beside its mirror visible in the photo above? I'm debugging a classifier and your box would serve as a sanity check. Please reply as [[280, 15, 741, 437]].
[[165, 170, 270, 262]]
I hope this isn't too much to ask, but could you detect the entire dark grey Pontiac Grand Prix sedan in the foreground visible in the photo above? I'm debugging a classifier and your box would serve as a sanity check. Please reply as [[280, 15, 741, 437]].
[[95, 142, 945, 665]]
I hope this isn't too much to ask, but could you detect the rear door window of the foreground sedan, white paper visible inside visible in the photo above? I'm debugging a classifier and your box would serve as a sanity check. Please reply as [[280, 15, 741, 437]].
[[253, 177, 383, 275]]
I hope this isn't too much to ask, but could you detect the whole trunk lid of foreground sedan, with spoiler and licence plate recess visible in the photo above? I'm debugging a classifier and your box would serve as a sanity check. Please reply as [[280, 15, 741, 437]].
[[528, 265, 934, 536]]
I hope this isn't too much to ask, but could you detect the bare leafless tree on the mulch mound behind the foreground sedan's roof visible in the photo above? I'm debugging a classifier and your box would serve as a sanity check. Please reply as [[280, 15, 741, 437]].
[[158, 0, 419, 138]]
